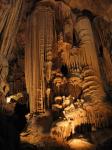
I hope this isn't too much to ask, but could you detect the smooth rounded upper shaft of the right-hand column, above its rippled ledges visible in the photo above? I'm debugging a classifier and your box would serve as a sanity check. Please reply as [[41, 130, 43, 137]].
[[76, 17, 100, 75]]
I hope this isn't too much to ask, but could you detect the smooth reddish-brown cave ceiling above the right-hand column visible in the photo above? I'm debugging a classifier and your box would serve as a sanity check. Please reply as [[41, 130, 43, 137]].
[[22, 0, 112, 21]]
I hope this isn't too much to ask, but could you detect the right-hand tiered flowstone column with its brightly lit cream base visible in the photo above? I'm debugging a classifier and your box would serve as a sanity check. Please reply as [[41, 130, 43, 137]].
[[48, 3, 112, 139]]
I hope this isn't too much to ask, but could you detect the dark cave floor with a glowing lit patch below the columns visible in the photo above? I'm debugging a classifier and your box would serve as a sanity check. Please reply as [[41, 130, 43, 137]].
[[20, 120, 112, 150]]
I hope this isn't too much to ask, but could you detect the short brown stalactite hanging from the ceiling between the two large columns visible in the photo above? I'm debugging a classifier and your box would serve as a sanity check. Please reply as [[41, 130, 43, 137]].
[[56, 1, 73, 45]]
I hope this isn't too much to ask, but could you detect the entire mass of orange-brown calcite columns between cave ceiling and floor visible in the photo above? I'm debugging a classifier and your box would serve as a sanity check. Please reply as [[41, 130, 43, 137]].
[[0, 0, 112, 142]]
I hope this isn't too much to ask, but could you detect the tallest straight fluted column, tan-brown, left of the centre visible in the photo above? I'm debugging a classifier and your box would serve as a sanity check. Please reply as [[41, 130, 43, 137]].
[[25, 1, 55, 113]]
